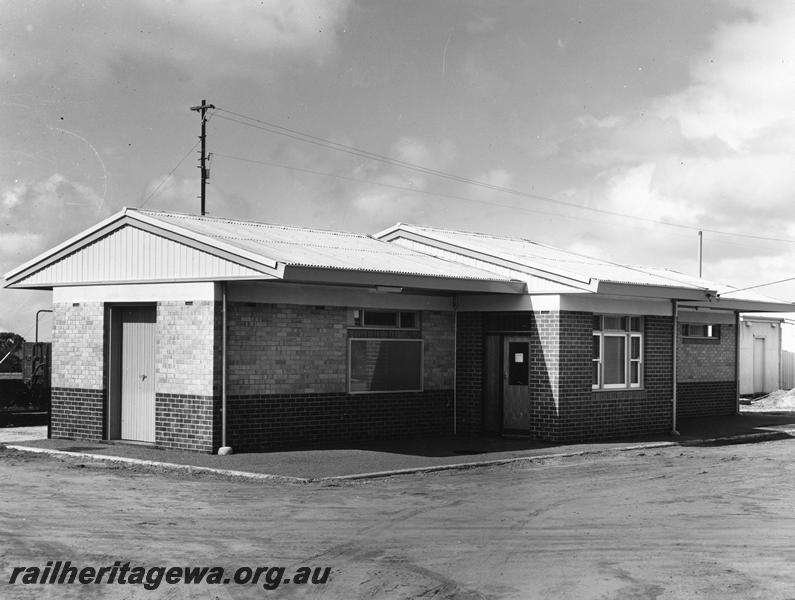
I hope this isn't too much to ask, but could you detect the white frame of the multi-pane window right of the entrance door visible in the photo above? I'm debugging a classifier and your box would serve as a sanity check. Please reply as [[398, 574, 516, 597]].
[[591, 314, 646, 391]]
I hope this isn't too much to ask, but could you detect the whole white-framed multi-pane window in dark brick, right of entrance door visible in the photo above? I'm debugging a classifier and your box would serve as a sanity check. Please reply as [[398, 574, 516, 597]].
[[591, 315, 643, 389]]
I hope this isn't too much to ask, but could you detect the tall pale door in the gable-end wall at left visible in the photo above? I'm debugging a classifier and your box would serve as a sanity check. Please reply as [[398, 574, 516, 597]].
[[121, 308, 155, 443]]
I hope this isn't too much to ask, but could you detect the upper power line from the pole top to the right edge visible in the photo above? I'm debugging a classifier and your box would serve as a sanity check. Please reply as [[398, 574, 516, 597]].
[[216, 108, 795, 243]]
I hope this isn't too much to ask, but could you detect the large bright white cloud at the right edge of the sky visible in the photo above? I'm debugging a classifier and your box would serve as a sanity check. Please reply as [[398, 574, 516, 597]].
[[559, 2, 795, 290]]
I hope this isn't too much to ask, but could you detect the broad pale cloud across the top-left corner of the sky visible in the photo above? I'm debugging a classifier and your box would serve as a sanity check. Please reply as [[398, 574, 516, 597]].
[[0, 0, 349, 83]]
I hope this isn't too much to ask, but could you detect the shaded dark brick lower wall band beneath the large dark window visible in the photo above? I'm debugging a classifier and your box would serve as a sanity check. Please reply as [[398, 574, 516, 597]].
[[227, 390, 453, 451]]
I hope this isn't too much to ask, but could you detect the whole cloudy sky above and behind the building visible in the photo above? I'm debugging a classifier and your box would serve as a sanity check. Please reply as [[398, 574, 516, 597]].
[[0, 0, 795, 338]]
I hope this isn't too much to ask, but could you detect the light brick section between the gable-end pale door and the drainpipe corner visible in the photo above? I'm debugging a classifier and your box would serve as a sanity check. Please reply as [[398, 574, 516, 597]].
[[156, 301, 220, 396]]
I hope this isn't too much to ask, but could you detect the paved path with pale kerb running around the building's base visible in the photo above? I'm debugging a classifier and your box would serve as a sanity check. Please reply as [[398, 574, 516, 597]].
[[6, 413, 795, 483]]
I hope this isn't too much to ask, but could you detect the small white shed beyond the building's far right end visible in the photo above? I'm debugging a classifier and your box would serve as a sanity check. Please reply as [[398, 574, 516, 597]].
[[740, 315, 792, 395]]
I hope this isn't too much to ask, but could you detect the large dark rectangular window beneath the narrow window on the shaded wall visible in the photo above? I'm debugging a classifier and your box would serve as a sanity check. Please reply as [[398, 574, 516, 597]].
[[348, 338, 423, 394]]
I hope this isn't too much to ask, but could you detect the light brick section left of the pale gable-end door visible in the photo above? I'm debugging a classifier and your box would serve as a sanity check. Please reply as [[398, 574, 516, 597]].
[[52, 302, 105, 390]]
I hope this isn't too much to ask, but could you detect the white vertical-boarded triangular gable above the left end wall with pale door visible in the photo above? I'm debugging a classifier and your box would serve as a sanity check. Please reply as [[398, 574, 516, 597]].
[[11, 225, 275, 288]]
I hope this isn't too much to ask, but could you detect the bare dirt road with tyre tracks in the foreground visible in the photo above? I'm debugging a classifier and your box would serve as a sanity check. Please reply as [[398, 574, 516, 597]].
[[0, 440, 795, 600]]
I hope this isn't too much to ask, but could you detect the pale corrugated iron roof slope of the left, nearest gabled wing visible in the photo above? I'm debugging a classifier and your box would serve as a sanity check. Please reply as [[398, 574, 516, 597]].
[[136, 210, 508, 281]]
